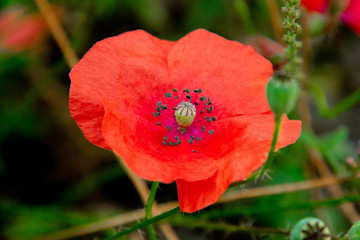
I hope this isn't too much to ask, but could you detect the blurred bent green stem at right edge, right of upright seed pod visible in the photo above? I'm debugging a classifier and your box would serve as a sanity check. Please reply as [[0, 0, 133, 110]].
[[308, 83, 360, 118]]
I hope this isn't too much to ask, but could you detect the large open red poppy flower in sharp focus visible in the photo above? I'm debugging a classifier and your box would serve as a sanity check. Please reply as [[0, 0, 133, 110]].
[[69, 30, 301, 212]]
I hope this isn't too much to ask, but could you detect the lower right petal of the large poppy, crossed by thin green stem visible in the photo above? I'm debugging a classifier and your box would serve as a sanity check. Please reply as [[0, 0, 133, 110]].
[[177, 113, 301, 213]]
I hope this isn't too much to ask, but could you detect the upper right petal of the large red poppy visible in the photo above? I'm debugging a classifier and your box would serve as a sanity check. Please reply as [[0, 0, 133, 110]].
[[168, 29, 273, 116]]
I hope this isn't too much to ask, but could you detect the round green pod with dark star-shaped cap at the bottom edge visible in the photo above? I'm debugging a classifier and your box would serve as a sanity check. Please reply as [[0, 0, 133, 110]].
[[290, 217, 331, 240]]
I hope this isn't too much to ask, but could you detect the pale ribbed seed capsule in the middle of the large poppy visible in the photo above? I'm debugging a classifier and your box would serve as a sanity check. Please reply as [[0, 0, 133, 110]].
[[174, 101, 196, 127]]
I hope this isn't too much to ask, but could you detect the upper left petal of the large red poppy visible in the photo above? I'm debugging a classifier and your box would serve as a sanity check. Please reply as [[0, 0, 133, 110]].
[[69, 30, 174, 149]]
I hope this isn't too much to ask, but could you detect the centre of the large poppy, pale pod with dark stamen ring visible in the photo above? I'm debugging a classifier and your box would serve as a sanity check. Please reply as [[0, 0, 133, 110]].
[[153, 88, 217, 153]]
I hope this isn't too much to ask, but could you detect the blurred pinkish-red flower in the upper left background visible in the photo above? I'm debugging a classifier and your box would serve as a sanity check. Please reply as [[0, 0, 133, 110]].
[[0, 8, 47, 51]]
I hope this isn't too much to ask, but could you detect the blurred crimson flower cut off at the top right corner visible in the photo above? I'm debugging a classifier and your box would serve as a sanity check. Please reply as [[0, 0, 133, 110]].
[[341, 0, 360, 35]]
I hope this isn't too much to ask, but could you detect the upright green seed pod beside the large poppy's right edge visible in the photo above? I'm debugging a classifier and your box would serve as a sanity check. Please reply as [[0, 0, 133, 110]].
[[266, 70, 299, 116]]
